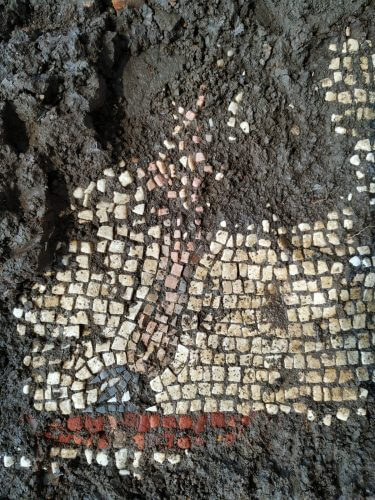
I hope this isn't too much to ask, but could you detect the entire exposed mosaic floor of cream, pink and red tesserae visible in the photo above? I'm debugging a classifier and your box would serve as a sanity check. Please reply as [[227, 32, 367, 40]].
[[4, 32, 375, 474]]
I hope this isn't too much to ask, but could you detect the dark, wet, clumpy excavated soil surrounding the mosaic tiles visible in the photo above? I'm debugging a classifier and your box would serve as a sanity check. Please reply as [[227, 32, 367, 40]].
[[0, 0, 375, 499]]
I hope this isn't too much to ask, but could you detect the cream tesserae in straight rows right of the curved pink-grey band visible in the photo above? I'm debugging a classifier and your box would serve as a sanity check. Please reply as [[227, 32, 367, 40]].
[[151, 213, 375, 419]]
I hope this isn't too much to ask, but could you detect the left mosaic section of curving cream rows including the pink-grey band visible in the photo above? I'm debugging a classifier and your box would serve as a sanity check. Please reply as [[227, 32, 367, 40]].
[[14, 88, 212, 415]]
